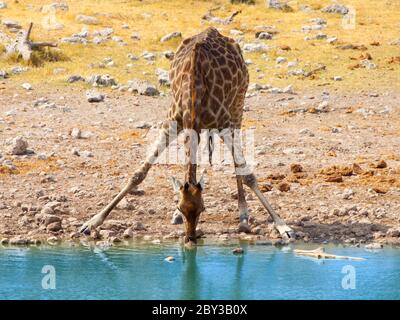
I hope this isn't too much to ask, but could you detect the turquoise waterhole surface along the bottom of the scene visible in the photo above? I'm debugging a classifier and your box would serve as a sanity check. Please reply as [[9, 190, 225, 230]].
[[0, 244, 400, 299]]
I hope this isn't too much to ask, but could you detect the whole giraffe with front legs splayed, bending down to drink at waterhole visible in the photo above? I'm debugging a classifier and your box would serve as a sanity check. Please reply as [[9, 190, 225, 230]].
[[80, 27, 294, 244]]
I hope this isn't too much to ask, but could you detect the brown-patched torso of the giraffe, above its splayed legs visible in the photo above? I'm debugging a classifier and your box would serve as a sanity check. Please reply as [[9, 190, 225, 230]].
[[169, 28, 249, 130]]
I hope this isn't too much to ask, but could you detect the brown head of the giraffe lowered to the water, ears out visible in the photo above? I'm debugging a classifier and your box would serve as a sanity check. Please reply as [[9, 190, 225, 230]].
[[172, 177, 205, 244]]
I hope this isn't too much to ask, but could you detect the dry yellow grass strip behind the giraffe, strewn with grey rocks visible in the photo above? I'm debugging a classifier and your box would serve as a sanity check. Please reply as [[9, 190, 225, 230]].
[[0, 0, 400, 89]]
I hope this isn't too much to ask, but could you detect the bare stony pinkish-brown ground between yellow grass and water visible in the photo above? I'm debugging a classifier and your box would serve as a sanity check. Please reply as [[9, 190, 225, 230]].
[[0, 81, 400, 244]]
